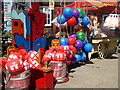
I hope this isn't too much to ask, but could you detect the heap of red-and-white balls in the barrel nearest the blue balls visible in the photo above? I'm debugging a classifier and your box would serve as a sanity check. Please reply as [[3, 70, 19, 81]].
[[42, 45, 76, 64]]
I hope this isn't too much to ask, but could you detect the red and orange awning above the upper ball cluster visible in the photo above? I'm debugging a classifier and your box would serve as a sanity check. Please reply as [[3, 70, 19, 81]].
[[57, 0, 118, 15]]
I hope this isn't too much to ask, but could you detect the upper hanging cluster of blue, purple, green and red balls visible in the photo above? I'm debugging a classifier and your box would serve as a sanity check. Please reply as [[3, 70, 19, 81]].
[[57, 7, 89, 26]]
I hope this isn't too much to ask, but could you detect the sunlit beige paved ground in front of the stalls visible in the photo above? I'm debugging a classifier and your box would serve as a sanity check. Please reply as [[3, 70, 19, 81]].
[[55, 54, 118, 88]]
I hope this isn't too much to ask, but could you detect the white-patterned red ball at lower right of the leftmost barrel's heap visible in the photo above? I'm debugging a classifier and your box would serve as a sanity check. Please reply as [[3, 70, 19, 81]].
[[28, 57, 41, 70]]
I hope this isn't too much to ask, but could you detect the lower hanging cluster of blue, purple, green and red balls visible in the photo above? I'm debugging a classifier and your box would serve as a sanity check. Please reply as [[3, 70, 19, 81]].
[[60, 31, 92, 62]]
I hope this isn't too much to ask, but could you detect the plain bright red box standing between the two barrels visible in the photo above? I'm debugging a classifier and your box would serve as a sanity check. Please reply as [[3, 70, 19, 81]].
[[30, 70, 54, 90]]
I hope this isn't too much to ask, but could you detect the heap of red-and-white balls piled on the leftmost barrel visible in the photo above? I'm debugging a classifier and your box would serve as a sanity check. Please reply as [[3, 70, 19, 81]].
[[0, 49, 41, 72]]
